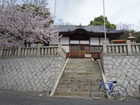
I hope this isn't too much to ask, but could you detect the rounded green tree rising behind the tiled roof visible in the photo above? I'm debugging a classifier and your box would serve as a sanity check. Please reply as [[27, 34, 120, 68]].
[[89, 15, 116, 29]]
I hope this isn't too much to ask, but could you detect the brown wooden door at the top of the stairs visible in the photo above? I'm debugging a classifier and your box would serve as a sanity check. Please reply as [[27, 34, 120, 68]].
[[70, 45, 90, 58]]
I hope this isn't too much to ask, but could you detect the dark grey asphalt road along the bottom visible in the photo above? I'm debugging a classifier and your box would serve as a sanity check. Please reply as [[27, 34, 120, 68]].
[[0, 91, 140, 105]]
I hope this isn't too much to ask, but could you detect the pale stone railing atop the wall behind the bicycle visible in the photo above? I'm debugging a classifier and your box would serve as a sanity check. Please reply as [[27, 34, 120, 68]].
[[103, 40, 140, 55]]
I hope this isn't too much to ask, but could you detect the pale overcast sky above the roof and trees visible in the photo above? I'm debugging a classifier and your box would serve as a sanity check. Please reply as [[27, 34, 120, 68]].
[[48, 0, 140, 30]]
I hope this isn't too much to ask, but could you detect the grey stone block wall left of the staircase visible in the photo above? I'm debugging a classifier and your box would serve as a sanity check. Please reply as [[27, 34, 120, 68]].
[[0, 56, 65, 93]]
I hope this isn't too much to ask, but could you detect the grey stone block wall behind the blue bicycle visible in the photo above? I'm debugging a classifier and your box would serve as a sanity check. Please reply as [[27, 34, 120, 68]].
[[102, 55, 140, 96]]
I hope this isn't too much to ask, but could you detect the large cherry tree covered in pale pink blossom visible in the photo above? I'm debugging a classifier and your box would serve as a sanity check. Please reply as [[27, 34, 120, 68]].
[[0, 0, 60, 46]]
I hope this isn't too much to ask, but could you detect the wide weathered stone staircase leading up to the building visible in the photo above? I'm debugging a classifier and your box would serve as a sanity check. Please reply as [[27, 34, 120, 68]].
[[54, 58, 102, 97]]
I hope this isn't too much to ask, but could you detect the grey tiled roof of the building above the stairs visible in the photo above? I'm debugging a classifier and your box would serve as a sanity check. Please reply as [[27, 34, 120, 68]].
[[57, 25, 123, 33]]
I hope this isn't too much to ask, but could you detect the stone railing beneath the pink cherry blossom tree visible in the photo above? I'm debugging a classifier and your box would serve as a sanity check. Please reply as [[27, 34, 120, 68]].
[[0, 46, 66, 58]]
